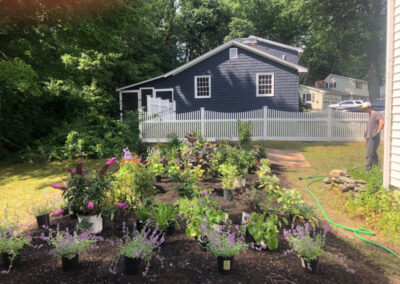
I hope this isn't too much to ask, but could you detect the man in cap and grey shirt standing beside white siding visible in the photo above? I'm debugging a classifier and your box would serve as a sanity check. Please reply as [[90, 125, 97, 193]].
[[361, 102, 384, 171]]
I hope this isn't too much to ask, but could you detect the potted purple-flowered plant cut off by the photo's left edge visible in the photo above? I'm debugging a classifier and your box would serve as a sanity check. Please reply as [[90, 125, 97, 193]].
[[0, 223, 31, 273]]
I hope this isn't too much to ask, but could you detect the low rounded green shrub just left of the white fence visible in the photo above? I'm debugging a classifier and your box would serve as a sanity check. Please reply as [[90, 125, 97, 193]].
[[21, 113, 147, 160]]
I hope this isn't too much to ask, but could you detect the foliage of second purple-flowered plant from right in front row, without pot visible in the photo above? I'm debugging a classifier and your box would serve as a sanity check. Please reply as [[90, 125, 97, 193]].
[[201, 219, 246, 258]]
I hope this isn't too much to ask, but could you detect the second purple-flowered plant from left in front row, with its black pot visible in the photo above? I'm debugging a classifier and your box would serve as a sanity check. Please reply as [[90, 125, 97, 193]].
[[40, 227, 97, 272]]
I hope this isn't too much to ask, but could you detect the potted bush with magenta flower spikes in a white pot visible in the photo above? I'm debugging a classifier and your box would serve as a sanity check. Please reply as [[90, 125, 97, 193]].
[[61, 158, 115, 233]]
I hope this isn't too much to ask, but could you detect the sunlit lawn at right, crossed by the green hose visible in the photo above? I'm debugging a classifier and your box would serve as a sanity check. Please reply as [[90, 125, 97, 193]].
[[267, 141, 400, 282]]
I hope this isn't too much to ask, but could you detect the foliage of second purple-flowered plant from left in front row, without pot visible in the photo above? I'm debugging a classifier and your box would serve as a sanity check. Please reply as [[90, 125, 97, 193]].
[[39, 225, 102, 259]]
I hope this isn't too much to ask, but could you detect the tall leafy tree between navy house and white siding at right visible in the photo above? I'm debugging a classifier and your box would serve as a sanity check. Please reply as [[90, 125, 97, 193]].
[[299, 0, 386, 101]]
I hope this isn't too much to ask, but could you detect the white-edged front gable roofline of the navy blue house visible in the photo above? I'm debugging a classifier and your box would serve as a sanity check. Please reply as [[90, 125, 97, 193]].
[[117, 40, 308, 91]]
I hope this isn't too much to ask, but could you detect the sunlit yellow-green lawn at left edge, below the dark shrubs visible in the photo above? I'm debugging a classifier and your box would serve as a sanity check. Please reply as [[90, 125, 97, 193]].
[[0, 159, 105, 230]]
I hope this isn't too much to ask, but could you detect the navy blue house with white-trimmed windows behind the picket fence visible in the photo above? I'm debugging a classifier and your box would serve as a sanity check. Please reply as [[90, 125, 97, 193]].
[[117, 36, 307, 116]]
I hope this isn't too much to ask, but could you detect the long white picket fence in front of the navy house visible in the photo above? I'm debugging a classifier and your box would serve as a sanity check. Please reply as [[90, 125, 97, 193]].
[[140, 107, 380, 142]]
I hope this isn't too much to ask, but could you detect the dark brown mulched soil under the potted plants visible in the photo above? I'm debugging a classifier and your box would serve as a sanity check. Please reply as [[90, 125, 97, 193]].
[[0, 172, 389, 284]]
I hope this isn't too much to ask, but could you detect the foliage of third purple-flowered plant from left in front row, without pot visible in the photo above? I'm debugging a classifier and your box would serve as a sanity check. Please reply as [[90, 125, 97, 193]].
[[109, 222, 165, 275]]
